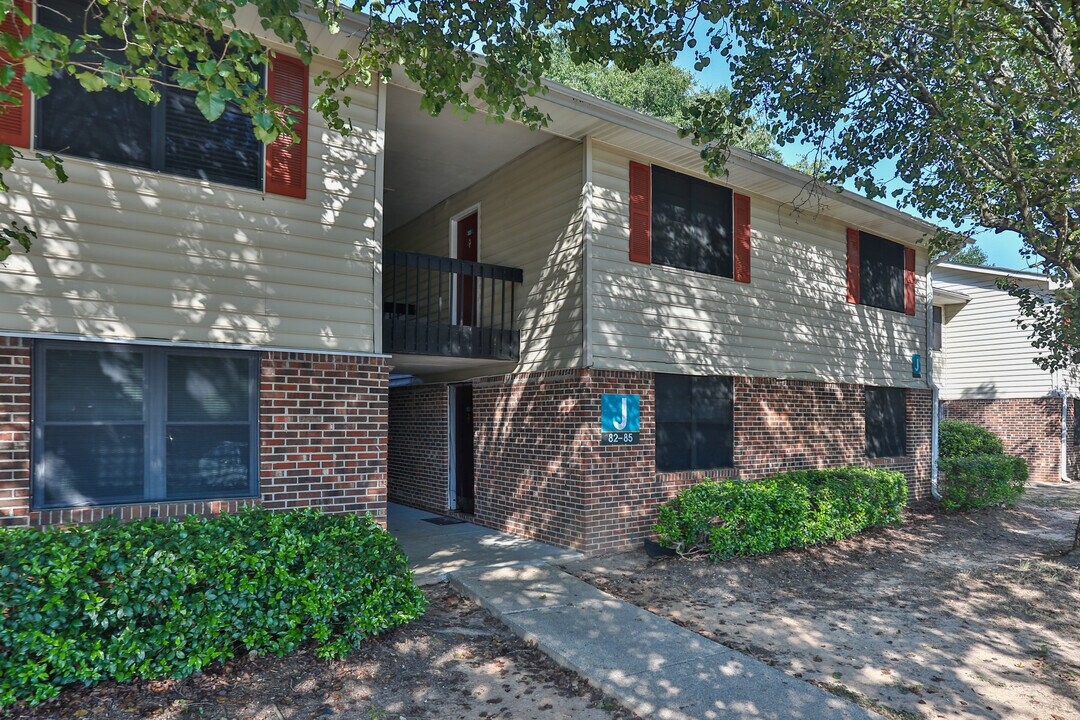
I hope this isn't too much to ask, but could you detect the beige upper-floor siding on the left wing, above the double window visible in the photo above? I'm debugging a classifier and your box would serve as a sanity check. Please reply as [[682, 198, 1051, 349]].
[[0, 62, 381, 353]]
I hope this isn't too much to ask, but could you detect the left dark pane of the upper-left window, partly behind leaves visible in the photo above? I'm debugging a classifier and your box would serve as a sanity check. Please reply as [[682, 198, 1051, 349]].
[[37, 0, 152, 167]]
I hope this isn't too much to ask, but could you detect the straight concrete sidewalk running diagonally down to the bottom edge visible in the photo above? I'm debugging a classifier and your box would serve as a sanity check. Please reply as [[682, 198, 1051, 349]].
[[450, 565, 881, 720]]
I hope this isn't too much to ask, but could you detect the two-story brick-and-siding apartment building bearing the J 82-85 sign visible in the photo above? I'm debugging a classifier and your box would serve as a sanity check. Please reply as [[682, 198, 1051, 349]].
[[0, 0, 933, 552]]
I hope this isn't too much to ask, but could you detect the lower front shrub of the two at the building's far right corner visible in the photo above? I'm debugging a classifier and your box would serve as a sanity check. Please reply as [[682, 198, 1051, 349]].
[[937, 454, 1027, 511]]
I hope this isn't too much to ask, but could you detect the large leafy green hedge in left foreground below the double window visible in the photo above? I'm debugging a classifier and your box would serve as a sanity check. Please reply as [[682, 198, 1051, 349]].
[[0, 510, 426, 707]]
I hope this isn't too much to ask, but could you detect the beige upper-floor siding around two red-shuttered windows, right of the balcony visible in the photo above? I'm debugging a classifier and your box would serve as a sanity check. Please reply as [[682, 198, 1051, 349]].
[[590, 144, 927, 388]]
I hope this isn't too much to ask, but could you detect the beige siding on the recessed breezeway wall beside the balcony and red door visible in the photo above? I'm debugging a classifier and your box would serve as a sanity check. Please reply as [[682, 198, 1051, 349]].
[[384, 139, 584, 371]]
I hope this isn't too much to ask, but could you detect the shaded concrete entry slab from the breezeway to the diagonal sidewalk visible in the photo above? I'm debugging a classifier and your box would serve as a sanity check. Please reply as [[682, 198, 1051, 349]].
[[387, 503, 581, 585]]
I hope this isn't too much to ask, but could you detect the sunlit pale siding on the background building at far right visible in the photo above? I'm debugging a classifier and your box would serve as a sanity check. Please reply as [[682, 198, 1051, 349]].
[[933, 268, 1053, 399]]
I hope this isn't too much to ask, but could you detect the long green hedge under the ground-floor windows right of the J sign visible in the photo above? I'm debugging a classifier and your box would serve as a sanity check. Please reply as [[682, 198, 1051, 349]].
[[653, 467, 907, 560]]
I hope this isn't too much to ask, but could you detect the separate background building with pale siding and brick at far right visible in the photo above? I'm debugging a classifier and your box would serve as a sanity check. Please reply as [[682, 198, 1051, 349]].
[[933, 262, 1080, 481]]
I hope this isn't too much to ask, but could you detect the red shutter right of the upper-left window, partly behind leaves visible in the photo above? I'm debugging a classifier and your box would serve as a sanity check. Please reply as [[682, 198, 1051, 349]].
[[266, 55, 308, 198]]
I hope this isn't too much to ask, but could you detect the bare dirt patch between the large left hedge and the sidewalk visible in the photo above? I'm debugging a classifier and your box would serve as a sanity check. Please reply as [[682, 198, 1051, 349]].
[[0, 585, 637, 720]]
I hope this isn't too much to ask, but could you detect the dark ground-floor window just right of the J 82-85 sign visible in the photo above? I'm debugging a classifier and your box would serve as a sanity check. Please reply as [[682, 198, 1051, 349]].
[[656, 373, 734, 472]]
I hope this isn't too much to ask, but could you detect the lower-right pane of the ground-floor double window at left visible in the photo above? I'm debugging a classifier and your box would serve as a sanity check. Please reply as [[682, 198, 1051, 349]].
[[165, 424, 252, 498]]
